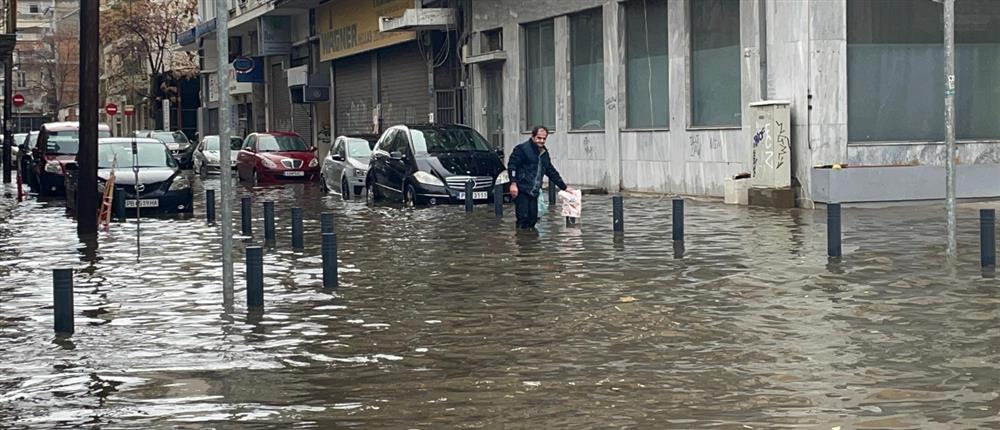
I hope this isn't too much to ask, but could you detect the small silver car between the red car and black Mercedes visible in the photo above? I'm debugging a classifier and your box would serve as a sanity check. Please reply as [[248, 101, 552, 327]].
[[319, 136, 375, 200]]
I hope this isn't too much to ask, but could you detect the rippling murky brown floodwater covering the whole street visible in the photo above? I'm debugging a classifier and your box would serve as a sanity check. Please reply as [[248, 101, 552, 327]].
[[0, 174, 1000, 429]]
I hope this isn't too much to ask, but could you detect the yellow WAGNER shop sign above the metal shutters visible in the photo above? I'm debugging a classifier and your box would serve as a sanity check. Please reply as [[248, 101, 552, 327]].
[[316, 0, 416, 61]]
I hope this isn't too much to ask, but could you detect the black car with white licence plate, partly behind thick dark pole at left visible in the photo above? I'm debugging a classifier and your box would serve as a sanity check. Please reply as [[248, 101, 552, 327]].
[[67, 137, 194, 214]]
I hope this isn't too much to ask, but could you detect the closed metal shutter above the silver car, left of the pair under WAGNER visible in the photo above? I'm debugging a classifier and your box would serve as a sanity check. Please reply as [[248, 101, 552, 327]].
[[333, 54, 375, 136]]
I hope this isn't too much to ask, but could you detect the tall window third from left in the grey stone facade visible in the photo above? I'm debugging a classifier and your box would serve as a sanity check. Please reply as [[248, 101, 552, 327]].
[[625, 0, 670, 128]]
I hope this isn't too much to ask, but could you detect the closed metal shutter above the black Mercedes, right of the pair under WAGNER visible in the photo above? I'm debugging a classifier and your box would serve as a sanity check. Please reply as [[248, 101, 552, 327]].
[[378, 42, 430, 129]]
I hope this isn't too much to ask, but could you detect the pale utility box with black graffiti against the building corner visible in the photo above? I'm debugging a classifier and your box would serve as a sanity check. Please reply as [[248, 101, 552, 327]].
[[750, 100, 792, 188]]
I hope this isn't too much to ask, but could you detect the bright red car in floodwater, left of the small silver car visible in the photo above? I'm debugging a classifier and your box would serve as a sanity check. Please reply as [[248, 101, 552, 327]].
[[236, 131, 319, 182]]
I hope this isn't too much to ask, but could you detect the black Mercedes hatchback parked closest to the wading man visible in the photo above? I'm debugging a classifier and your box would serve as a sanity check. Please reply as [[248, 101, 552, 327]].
[[365, 124, 510, 206]]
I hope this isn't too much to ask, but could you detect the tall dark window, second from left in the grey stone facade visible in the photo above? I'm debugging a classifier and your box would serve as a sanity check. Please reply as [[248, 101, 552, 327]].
[[569, 9, 604, 130]]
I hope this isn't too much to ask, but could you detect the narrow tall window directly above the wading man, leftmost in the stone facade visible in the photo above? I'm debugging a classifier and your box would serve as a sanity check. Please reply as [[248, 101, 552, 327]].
[[524, 20, 556, 129]]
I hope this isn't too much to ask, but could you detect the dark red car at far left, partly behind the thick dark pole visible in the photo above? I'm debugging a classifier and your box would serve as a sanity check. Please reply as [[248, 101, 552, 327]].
[[31, 122, 111, 196]]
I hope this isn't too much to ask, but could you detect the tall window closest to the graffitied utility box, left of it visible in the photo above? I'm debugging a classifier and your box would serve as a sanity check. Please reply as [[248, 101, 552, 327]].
[[691, 0, 742, 127]]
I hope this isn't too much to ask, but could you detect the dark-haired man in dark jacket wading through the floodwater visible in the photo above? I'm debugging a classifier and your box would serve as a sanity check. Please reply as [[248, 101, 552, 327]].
[[507, 126, 570, 230]]
